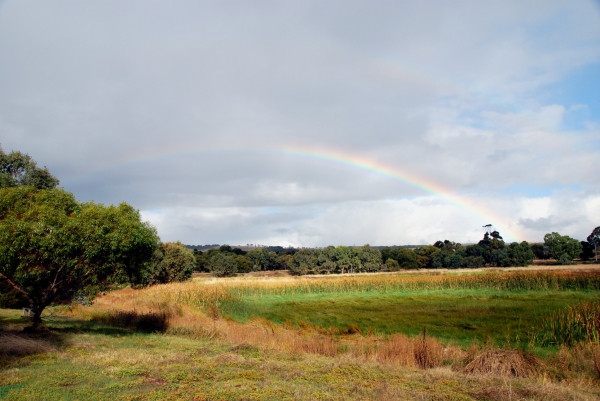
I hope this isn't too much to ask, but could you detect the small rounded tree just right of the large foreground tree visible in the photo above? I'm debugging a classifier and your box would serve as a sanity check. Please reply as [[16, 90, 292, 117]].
[[149, 241, 196, 284]]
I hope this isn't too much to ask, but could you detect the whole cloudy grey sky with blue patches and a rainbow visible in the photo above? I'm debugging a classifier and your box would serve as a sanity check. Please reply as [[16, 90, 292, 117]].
[[0, 0, 600, 247]]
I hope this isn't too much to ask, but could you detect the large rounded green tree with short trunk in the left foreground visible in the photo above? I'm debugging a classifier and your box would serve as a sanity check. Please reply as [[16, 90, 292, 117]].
[[0, 187, 158, 327]]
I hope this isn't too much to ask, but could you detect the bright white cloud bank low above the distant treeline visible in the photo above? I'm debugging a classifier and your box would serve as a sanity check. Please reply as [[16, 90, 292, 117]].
[[142, 190, 600, 246]]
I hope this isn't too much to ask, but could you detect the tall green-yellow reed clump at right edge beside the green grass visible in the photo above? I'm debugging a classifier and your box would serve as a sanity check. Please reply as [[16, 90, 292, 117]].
[[541, 301, 600, 346]]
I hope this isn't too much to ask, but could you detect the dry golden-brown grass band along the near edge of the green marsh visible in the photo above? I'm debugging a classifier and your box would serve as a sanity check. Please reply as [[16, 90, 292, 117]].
[[71, 290, 450, 368]]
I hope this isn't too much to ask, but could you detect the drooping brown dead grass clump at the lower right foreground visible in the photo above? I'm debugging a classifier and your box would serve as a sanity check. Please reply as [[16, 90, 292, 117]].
[[465, 348, 541, 377]]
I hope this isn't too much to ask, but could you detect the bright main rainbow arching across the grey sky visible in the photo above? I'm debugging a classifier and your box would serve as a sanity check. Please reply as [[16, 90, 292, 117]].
[[67, 144, 523, 241]]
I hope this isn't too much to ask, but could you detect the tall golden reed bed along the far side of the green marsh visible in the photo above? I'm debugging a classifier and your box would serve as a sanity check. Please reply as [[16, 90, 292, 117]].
[[88, 271, 600, 316]]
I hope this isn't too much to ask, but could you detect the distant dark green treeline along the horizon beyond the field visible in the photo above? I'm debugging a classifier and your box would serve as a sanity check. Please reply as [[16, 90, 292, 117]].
[[194, 228, 600, 276]]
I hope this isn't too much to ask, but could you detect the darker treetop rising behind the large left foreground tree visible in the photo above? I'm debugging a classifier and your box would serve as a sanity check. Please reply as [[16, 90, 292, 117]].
[[0, 147, 59, 189]]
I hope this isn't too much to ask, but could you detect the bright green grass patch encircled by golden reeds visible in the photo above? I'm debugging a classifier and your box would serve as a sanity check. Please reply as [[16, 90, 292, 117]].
[[229, 290, 600, 346]]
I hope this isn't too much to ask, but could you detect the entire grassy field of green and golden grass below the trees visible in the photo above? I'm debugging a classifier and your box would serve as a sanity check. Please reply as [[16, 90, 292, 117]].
[[0, 271, 600, 400]]
